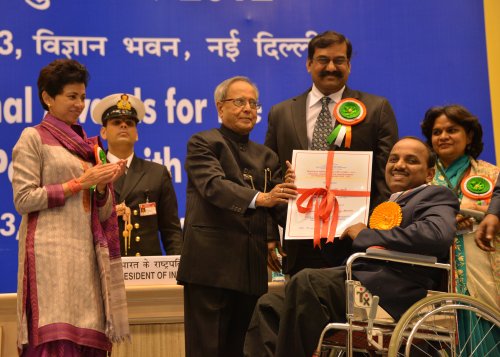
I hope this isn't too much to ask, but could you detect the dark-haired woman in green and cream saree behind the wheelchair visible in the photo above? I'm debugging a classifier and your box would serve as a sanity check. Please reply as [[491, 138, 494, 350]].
[[421, 105, 500, 355]]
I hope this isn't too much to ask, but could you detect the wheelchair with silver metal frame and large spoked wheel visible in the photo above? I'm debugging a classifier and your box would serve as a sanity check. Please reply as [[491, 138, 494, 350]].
[[313, 248, 500, 357]]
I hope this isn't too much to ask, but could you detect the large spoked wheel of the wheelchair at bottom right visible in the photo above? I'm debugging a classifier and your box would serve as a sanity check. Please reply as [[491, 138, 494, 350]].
[[389, 293, 500, 357]]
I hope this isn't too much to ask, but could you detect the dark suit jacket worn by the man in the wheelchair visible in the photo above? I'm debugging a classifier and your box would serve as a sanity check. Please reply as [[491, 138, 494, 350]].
[[352, 186, 459, 318]]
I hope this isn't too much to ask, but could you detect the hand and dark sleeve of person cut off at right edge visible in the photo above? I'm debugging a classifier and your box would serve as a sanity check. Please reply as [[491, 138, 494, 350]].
[[475, 176, 500, 252]]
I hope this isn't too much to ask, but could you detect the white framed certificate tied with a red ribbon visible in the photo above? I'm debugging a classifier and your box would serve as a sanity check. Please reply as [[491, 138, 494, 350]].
[[285, 150, 373, 245]]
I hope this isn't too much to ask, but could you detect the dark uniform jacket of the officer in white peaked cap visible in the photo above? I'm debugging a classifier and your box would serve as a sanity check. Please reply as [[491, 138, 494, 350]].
[[115, 155, 182, 256]]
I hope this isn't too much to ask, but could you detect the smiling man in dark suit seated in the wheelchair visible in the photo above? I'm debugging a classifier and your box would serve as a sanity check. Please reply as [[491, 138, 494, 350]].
[[245, 137, 459, 357]]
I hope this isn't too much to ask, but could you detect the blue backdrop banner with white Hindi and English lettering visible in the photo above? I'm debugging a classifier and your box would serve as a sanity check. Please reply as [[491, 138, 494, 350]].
[[0, 0, 495, 293]]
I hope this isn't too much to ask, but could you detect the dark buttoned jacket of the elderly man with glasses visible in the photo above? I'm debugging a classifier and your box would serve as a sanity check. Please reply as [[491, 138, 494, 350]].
[[177, 127, 286, 296]]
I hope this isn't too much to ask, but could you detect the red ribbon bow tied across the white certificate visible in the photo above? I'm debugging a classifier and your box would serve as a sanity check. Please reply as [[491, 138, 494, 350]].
[[297, 151, 370, 247]]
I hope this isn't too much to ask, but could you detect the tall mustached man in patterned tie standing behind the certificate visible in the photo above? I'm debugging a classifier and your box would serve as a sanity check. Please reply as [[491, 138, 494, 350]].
[[265, 31, 398, 274]]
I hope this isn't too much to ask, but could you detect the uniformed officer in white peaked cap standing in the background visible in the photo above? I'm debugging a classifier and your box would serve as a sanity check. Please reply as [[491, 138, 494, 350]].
[[92, 93, 182, 256]]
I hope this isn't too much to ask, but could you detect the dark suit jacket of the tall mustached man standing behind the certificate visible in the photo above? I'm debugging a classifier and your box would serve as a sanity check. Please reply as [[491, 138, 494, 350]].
[[265, 87, 398, 272]]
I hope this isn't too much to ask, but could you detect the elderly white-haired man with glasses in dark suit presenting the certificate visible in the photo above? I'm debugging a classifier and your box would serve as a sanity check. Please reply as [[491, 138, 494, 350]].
[[177, 77, 296, 357]]
